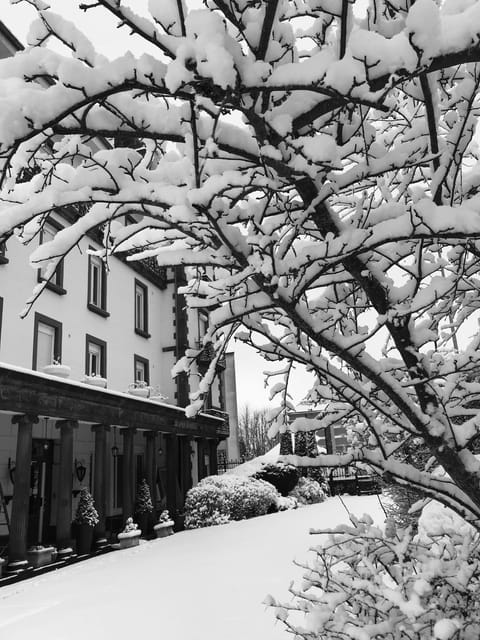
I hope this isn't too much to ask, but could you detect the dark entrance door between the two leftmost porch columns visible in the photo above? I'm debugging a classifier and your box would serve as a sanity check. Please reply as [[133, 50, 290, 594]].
[[28, 438, 53, 545]]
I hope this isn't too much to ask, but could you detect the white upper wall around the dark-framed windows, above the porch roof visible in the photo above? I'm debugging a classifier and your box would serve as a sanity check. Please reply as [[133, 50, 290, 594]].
[[0, 225, 175, 404]]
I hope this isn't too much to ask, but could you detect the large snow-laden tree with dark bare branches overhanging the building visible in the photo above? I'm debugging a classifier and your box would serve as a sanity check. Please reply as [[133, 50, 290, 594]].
[[4, 0, 480, 527]]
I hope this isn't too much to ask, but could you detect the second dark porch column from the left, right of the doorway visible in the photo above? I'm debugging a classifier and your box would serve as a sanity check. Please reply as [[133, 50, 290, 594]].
[[56, 420, 78, 558]]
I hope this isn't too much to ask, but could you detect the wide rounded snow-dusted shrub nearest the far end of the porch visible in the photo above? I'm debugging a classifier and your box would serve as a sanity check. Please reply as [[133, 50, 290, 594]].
[[185, 475, 278, 529]]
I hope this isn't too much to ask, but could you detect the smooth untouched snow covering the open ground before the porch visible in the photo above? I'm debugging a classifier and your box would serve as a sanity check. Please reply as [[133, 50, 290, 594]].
[[0, 496, 384, 640]]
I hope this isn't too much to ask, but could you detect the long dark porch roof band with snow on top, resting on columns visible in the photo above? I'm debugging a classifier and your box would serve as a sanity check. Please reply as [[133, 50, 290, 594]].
[[0, 363, 229, 438]]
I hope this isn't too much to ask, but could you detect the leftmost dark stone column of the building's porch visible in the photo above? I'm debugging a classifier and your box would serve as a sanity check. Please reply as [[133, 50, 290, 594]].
[[8, 415, 38, 571]]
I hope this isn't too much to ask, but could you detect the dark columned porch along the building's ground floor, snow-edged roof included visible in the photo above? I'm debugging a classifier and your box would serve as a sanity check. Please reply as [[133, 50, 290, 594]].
[[0, 365, 228, 571]]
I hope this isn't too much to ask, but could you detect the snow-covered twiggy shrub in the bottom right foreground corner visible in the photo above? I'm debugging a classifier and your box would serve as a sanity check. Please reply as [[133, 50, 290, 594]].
[[265, 506, 480, 640]]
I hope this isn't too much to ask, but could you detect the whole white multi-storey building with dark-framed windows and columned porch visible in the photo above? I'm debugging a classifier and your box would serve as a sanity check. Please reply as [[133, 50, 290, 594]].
[[0, 23, 236, 569]]
